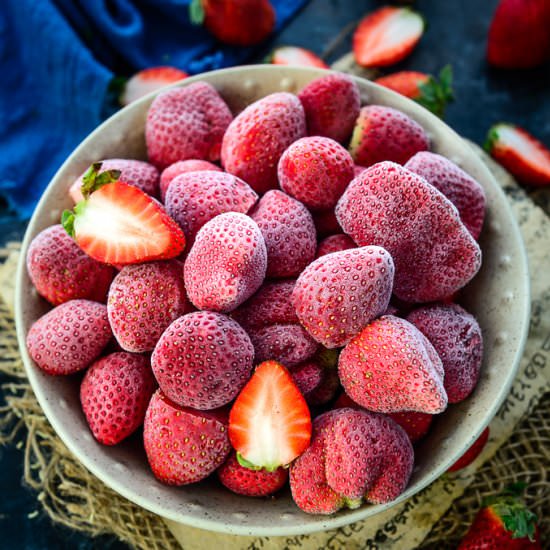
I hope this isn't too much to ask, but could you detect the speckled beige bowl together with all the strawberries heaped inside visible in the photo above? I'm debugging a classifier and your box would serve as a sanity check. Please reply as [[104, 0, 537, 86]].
[[16, 66, 529, 535]]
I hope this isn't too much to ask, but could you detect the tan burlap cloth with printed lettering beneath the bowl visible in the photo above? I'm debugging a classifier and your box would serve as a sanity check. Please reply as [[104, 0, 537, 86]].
[[0, 143, 550, 550]]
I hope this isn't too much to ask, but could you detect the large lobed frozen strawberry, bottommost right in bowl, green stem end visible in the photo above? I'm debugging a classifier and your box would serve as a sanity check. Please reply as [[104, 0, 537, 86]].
[[290, 408, 414, 514]]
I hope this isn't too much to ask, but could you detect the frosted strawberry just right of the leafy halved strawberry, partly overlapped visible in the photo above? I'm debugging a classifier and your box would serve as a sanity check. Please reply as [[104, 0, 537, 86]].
[[164, 170, 258, 246]]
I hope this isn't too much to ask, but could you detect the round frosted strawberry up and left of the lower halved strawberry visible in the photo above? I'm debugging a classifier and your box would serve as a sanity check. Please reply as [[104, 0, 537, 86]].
[[151, 311, 254, 410]]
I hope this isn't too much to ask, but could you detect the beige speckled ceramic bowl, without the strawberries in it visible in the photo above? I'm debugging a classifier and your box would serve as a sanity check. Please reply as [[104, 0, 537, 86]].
[[16, 65, 529, 535]]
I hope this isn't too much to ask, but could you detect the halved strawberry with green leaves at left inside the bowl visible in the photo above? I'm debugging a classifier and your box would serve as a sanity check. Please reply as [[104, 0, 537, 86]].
[[61, 162, 185, 265]]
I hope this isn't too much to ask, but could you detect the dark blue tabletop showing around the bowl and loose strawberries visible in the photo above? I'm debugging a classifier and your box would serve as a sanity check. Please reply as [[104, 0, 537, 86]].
[[0, 0, 550, 550]]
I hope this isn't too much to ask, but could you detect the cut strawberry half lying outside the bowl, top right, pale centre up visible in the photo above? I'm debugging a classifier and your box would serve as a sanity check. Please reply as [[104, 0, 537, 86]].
[[353, 6, 425, 67]]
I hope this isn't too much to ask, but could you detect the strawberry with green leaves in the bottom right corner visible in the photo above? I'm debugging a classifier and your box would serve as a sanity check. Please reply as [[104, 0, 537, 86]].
[[458, 483, 542, 550]]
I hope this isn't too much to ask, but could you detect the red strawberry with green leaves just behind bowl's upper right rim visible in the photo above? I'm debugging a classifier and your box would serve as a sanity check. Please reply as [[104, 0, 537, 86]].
[[375, 65, 454, 118]]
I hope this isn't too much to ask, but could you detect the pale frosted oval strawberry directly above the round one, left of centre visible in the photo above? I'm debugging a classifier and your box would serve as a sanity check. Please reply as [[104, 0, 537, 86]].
[[184, 212, 267, 312]]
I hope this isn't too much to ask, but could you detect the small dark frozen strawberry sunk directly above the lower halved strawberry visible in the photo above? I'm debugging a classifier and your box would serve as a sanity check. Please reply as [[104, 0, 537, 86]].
[[248, 324, 319, 368]]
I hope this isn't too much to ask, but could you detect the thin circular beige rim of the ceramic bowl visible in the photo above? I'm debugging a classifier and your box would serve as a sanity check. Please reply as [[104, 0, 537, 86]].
[[15, 65, 530, 536]]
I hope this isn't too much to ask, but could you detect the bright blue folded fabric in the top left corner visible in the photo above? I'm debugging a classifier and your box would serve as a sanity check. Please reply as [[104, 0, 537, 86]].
[[0, 0, 306, 219]]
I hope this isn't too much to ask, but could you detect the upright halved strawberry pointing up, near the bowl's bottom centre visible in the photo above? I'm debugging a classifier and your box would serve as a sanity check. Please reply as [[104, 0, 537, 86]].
[[229, 361, 311, 472]]
